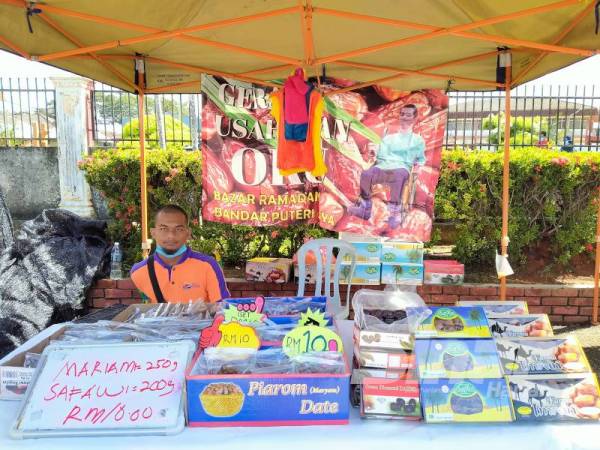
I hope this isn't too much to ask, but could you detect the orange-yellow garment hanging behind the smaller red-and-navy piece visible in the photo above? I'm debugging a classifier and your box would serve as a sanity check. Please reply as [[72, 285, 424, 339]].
[[271, 90, 327, 177]]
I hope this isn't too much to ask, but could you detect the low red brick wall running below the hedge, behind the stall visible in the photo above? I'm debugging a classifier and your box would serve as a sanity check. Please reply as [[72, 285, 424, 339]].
[[88, 279, 594, 325]]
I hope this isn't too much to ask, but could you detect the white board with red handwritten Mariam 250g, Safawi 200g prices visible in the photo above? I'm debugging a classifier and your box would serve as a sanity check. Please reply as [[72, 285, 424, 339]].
[[13, 342, 193, 437]]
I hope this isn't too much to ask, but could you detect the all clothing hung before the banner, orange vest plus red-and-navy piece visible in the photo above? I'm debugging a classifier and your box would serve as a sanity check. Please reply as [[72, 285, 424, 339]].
[[271, 69, 327, 177]]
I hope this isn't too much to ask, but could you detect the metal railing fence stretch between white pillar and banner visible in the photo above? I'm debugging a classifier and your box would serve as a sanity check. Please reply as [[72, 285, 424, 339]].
[[92, 82, 201, 148]]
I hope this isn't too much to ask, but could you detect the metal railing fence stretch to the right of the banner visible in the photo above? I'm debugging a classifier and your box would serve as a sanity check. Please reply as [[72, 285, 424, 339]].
[[444, 86, 600, 151]]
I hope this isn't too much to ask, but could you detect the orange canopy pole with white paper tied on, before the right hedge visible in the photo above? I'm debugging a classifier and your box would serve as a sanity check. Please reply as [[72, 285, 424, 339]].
[[500, 53, 512, 300]]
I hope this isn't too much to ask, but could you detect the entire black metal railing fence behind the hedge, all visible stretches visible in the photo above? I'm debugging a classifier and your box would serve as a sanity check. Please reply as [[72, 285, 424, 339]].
[[0, 78, 600, 151]]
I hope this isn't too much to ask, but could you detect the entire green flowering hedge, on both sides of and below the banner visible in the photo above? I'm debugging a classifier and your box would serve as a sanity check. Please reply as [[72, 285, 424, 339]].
[[80, 147, 600, 270]]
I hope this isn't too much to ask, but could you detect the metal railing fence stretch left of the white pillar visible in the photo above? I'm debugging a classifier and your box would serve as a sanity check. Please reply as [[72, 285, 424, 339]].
[[0, 78, 56, 147]]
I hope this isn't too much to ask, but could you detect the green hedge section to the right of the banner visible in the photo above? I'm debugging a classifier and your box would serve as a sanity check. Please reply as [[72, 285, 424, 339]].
[[435, 147, 600, 269]]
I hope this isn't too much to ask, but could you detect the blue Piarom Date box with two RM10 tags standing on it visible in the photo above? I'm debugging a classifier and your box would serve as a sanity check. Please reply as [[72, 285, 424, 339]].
[[186, 309, 351, 427]]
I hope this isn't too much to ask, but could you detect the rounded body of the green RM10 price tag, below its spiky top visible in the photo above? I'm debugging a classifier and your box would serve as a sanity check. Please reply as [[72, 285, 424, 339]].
[[282, 326, 344, 356]]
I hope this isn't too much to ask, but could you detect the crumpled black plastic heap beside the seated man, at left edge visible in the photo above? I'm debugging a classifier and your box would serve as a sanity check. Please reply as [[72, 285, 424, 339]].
[[0, 209, 110, 357]]
